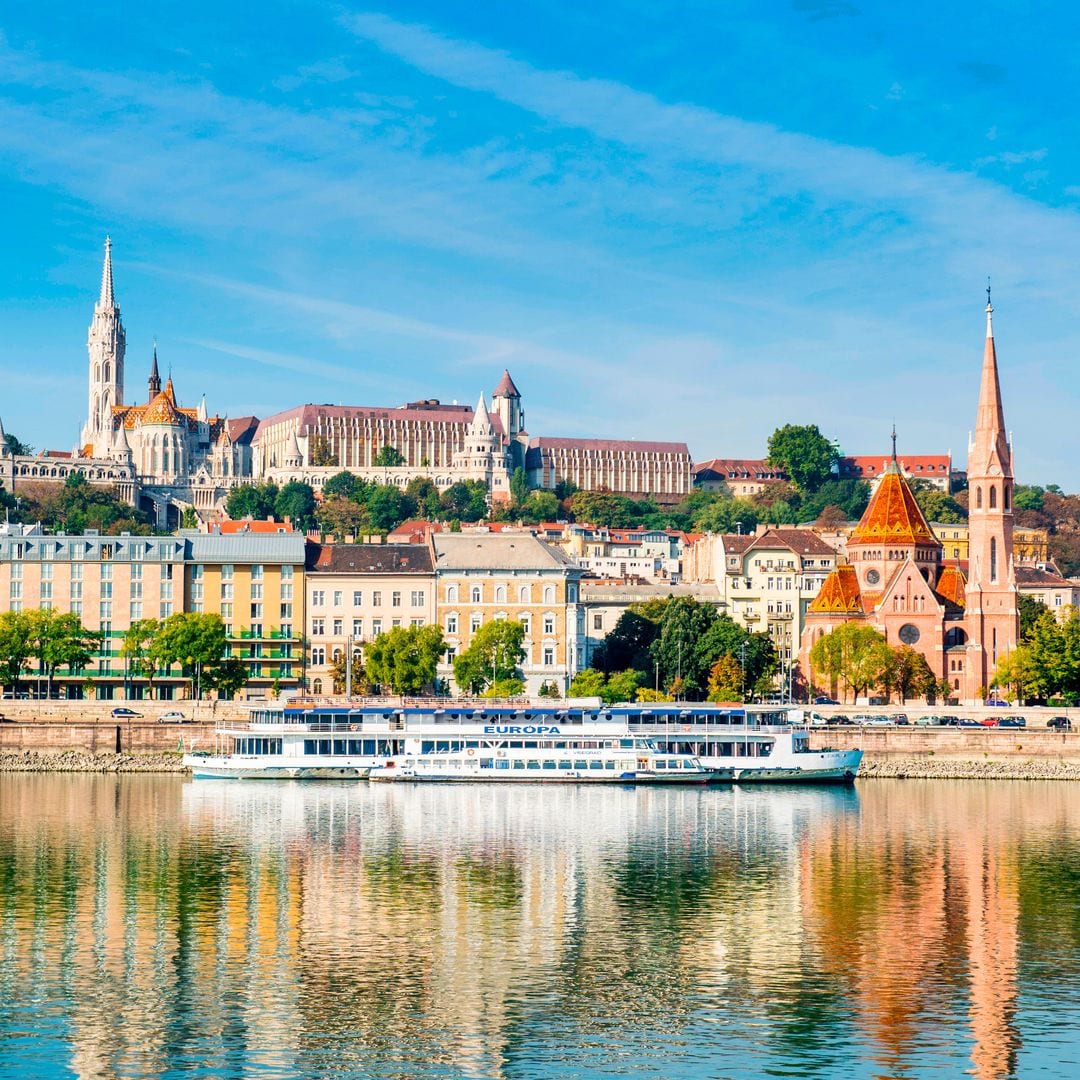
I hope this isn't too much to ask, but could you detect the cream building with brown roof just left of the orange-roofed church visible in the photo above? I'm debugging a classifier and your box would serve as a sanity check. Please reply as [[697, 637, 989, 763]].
[[683, 528, 837, 666]]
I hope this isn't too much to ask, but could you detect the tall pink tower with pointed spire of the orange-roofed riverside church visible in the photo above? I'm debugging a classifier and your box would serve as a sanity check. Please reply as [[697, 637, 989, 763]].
[[964, 289, 1020, 700]]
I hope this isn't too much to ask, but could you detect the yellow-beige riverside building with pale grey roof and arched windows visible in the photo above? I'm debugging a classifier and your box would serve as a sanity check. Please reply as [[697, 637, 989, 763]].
[[432, 532, 585, 694]]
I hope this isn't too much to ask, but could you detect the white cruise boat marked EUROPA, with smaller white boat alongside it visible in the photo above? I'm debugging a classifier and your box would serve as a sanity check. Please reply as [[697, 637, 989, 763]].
[[184, 699, 862, 784]]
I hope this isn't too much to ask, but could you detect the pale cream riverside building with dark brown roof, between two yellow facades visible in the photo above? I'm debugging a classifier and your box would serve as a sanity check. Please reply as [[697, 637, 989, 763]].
[[306, 543, 435, 694]]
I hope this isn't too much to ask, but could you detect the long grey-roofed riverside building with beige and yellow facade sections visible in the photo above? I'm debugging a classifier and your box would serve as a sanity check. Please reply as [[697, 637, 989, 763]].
[[0, 529, 303, 699]]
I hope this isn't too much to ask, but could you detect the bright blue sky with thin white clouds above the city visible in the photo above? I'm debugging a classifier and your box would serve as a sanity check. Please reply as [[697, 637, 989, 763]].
[[0, 0, 1080, 490]]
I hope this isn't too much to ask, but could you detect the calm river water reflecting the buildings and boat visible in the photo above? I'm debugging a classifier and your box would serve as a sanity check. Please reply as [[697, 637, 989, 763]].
[[0, 774, 1080, 1080]]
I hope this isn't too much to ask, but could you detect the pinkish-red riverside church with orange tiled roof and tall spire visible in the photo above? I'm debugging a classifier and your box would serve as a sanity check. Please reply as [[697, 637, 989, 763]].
[[799, 302, 1020, 703]]
